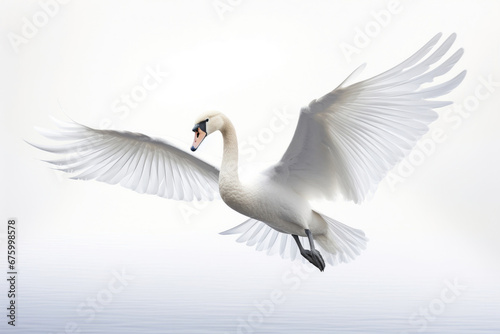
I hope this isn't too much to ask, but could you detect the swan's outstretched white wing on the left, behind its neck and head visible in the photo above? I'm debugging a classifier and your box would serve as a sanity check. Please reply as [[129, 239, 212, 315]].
[[31, 120, 219, 201]]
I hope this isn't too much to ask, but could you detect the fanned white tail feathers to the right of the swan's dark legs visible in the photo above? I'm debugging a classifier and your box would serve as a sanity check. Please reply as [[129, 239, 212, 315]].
[[314, 211, 368, 265]]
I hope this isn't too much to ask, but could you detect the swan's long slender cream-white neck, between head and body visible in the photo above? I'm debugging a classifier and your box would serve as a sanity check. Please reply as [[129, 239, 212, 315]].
[[219, 116, 243, 206]]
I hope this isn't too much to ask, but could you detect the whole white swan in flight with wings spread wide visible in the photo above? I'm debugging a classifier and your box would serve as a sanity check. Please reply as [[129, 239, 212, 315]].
[[33, 34, 466, 271]]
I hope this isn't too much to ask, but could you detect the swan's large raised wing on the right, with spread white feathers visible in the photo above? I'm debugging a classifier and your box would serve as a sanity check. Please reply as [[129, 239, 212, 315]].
[[268, 34, 465, 203]]
